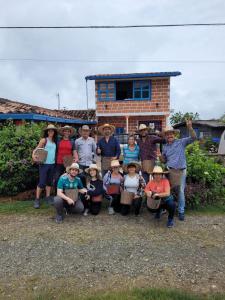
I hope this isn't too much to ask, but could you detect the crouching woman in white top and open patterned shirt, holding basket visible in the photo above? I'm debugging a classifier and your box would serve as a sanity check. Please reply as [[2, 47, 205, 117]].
[[120, 161, 146, 216]]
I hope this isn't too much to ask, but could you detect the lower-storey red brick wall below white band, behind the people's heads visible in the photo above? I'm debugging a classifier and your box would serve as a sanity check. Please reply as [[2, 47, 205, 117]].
[[98, 116, 166, 133]]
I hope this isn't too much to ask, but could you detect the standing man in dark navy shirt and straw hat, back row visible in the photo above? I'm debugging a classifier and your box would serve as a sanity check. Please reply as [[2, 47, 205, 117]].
[[97, 124, 121, 176]]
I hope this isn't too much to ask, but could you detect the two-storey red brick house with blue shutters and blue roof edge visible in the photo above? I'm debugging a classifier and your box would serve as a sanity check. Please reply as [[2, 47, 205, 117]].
[[85, 72, 181, 134]]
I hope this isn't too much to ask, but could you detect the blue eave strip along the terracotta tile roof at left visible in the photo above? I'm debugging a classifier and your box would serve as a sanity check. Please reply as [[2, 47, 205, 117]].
[[0, 113, 97, 124]]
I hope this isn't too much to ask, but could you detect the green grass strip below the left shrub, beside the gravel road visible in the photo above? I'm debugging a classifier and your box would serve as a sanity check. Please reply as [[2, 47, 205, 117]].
[[0, 200, 52, 215]]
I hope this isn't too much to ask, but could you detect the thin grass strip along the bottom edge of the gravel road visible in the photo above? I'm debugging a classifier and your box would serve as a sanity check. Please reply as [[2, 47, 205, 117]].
[[34, 289, 225, 300]]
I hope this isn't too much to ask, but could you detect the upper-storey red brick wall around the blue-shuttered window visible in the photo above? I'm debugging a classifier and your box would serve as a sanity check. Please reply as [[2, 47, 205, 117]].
[[96, 78, 170, 115]]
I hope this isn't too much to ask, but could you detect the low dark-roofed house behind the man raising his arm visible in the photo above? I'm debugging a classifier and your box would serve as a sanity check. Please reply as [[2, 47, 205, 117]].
[[173, 120, 225, 142]]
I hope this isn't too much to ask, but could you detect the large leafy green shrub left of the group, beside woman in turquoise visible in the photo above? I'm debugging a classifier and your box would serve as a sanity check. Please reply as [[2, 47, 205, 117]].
[[0, 122, 45, 195]]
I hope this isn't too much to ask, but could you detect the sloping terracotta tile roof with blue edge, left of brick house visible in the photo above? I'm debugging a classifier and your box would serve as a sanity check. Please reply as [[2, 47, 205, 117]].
[[0, 98, 96, 128]]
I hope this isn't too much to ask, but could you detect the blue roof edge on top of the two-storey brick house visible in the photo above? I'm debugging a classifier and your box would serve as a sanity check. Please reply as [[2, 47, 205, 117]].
[[85, 71, 181, 80]]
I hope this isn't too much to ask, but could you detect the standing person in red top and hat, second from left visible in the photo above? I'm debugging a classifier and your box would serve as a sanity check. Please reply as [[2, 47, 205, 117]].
[[54, 125, 77, 187]]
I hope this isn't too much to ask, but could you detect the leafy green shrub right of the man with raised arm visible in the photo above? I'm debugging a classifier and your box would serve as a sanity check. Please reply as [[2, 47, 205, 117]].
[[186, 142, 225, 208]]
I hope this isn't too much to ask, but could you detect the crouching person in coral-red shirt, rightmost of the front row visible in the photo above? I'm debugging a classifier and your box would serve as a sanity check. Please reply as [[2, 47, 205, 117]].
[[145, 166, 176, 228]]
